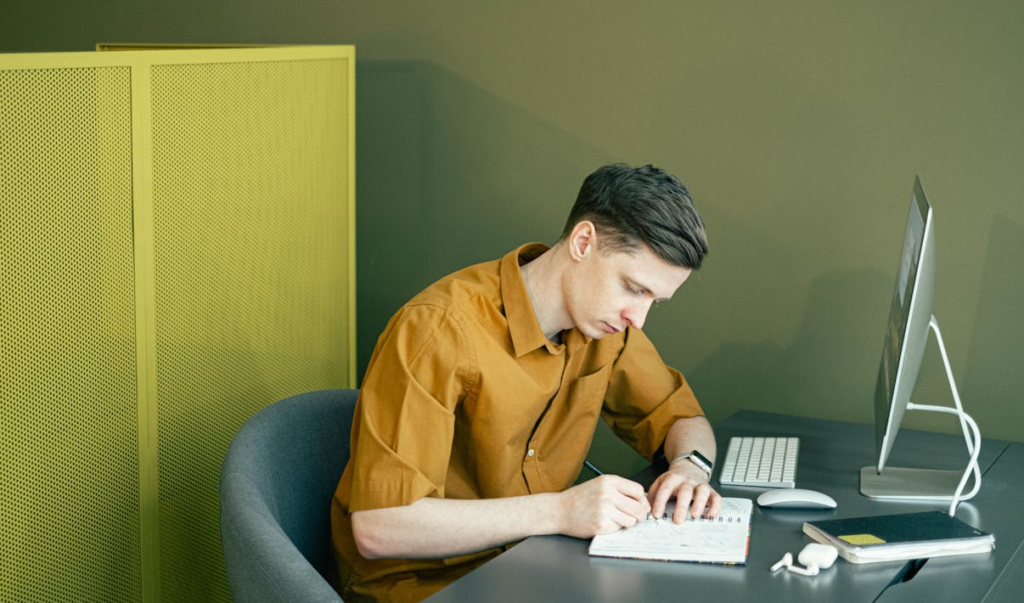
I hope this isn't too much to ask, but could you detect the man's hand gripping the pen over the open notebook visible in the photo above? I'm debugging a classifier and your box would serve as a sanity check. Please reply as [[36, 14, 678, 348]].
[[559, 475, 650, 539]]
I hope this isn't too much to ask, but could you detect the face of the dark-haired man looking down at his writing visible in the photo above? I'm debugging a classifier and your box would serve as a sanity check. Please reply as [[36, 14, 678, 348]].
[[564, 245, 690, 339]]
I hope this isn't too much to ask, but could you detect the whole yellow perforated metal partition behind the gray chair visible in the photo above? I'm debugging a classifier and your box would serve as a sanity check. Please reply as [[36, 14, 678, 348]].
[[0, 47, 355, 602]]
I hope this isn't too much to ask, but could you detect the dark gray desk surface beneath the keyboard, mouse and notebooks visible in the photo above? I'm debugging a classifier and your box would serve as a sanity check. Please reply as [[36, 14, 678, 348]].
[[428, 412, 1024, 603]]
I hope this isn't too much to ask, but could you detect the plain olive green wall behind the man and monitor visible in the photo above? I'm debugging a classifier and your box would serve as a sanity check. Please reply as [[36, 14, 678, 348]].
[[0, 0, 1024, 471]]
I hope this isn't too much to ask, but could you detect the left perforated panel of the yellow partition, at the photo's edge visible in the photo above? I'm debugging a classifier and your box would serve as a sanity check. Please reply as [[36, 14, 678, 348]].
[[0, 68, 141, 602]]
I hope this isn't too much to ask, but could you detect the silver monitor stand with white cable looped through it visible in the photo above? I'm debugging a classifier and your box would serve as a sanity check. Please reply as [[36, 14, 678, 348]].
[[860, 314, 981, 515]]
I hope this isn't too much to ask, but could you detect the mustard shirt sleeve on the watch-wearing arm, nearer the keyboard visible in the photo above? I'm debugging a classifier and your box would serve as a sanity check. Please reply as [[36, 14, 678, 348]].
[[602, 328, 703, 461]]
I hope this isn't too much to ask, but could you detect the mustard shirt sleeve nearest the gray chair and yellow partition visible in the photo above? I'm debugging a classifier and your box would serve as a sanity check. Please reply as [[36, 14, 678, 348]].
[[348, 304, 473, 512]]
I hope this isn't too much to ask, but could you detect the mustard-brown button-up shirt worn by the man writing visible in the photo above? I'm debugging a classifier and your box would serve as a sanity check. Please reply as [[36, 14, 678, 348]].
[[331, 244, 702, 603]]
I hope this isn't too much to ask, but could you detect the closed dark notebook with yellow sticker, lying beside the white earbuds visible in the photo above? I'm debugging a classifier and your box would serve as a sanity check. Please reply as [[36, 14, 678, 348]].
[[804, 511, 995, 563]]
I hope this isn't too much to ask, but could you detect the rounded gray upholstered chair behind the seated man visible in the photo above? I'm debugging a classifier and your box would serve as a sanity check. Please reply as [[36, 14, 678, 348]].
[[220, 389, 358, 603]]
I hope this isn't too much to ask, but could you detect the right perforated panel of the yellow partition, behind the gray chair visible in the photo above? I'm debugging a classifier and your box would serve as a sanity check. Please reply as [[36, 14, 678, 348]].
[[152, 55, 351, 602]]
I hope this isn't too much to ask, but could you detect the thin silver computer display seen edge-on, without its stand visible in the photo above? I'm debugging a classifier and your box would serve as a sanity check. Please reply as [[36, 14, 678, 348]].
[[874, 177, 935, 473]]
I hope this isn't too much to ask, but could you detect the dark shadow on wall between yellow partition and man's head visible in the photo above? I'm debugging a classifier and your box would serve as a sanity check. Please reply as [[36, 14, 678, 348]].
[[356, 60, 614, 380]]
